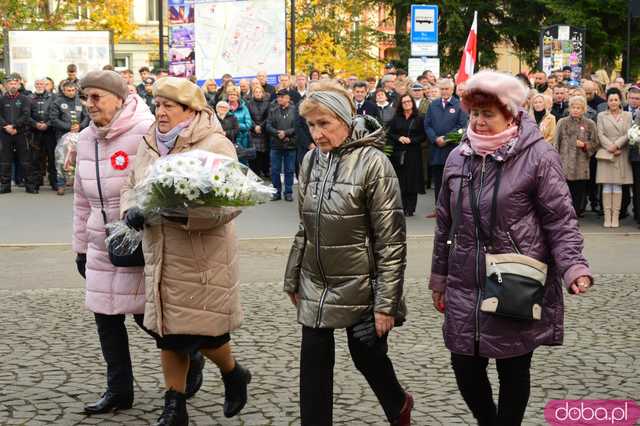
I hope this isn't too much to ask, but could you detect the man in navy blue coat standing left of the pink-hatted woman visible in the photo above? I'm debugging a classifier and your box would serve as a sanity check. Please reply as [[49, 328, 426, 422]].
[[424, 78, 469, 218]]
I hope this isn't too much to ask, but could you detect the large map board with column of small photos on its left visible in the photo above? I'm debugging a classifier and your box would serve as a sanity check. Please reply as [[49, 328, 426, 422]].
[[168, 0, 287, 83]]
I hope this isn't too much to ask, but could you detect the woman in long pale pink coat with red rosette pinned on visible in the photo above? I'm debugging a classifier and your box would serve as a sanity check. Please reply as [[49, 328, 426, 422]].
[[73, 71, 204, 414]]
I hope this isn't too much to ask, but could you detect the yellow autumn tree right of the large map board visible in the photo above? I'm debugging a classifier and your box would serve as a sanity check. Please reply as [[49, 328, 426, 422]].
[[296, 0, 381, 78]]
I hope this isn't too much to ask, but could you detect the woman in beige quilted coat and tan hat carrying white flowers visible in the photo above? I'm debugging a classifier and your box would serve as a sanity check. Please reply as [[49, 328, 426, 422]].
[[121, 77, 251, 426]]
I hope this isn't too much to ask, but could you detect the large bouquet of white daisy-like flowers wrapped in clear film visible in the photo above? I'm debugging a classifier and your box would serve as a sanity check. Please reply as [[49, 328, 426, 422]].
[[135, 150, 275, 218]]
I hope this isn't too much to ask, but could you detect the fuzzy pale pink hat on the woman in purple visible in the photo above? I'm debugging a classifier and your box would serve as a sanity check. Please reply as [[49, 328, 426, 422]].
[[465, 70, 529, 117]]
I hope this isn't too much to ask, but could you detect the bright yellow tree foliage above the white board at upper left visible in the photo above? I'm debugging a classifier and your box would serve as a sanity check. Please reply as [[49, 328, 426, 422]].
[[76, 0, 137, 43]]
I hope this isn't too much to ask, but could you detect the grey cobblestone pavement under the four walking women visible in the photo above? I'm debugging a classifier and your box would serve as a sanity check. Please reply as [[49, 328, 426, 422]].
[[0, 275, 640, 426]]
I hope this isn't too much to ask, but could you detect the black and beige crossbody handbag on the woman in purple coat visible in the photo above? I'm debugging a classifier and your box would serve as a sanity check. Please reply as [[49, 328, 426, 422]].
[[449, 161, 547, 320]]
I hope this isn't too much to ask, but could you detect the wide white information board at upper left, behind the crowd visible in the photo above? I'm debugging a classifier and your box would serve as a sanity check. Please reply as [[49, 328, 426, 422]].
[[5, 31, 113, 87]]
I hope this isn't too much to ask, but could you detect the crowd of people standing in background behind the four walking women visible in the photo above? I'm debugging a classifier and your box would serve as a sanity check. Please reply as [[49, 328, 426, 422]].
[[0, 64, 640, 227]]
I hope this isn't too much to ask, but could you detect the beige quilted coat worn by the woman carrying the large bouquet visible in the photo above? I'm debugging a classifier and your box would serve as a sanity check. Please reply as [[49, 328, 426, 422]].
[[121, 110, 242, 336]]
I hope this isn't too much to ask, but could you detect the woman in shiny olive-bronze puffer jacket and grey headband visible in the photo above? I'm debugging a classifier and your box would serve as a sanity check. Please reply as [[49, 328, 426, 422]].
[[284, 82, 413, 426]]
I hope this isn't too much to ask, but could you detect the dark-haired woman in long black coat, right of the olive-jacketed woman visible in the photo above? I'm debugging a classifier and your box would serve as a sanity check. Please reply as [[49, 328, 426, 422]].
[[387, 94, 427, 216]]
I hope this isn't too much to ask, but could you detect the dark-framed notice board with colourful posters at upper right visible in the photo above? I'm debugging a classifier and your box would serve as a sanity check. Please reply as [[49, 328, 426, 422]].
[[540, 25, 585, 84]]
